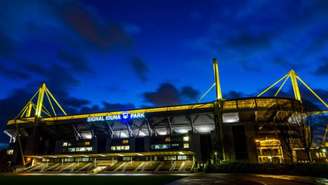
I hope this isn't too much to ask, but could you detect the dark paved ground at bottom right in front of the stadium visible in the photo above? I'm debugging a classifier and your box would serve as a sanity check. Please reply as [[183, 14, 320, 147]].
[[169, 174, 328, 185]]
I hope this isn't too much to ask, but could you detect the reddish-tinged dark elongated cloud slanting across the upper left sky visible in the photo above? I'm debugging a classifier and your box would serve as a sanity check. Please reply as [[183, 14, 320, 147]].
[[53, 2, 132, 50]]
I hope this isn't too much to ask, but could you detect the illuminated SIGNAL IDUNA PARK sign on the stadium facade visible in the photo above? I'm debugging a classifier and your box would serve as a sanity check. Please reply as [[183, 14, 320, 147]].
[[87, 112, 145, 122]]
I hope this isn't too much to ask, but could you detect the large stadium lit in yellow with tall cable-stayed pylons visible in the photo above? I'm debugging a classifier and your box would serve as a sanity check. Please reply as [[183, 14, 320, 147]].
[[5, 59, 328, 174]]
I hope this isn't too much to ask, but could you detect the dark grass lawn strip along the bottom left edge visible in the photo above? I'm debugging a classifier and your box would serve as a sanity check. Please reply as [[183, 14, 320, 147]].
[[0, 175, 182, 185]]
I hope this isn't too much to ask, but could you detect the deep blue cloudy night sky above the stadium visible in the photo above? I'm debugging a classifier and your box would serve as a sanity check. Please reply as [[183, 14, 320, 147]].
[[0, 0, 328, 143]]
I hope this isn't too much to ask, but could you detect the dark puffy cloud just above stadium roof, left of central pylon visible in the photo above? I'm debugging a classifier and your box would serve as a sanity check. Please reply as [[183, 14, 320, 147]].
[[143, 83, 199, 106]]
